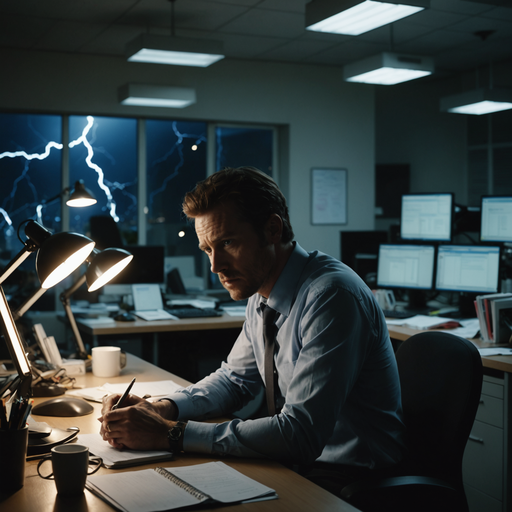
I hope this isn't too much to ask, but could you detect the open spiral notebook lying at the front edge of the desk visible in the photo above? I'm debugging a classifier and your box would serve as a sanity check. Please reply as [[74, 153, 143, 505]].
[[86, 462, 277, 512]]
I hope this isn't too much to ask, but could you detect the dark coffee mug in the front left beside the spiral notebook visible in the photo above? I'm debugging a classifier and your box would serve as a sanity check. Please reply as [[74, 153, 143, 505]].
[[37, 444, 102, 495]]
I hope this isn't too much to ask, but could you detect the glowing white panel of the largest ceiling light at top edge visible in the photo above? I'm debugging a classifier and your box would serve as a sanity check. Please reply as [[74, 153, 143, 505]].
[[306, 0, 424, 36]]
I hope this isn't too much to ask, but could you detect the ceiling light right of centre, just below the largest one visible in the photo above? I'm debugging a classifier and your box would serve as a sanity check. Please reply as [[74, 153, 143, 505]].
[[343, 52, 434, 85]]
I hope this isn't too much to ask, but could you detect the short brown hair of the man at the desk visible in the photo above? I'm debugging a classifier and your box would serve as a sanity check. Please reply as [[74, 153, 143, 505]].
[[183, 167, 294, 243]]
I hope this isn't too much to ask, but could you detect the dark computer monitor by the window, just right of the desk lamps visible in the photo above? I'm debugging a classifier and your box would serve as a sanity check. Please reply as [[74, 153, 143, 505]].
[[103, 245, 165, 295]]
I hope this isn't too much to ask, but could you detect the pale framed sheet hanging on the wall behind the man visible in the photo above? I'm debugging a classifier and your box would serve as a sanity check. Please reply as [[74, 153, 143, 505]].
[[311, 169, 347, 225]]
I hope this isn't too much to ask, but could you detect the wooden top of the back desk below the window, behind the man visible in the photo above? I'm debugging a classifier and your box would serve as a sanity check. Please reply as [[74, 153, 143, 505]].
[[76, 313, 245, 335]]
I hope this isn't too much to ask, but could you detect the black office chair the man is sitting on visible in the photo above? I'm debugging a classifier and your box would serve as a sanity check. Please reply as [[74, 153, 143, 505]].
[[341, 332, 483, 512]]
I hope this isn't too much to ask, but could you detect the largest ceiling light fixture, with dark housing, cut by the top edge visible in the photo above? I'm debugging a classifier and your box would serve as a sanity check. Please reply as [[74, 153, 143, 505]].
[[306, 0, 429, 36]]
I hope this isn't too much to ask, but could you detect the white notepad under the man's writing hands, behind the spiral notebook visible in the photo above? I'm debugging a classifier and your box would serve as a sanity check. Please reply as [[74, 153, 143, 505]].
[[77, 434, 172, 467]]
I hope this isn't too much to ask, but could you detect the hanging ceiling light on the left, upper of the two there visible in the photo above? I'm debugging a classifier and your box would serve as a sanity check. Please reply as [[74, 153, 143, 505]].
[[125, 34, 224, 68]]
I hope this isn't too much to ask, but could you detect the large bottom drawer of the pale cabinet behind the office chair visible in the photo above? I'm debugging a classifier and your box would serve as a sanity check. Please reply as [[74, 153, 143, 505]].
[[462, 421, 503, 501]]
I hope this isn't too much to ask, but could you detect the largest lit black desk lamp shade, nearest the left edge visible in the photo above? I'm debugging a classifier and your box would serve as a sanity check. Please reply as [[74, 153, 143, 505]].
[[36, 233, 95, 288]]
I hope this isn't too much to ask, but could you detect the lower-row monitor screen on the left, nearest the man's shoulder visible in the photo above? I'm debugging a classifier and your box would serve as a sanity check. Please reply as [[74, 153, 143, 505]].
[[377, 244, 435, 290]]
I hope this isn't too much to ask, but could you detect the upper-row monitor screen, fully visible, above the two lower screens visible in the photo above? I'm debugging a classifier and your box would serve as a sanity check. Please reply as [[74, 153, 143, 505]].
[[400, 194, 453, 242]]
